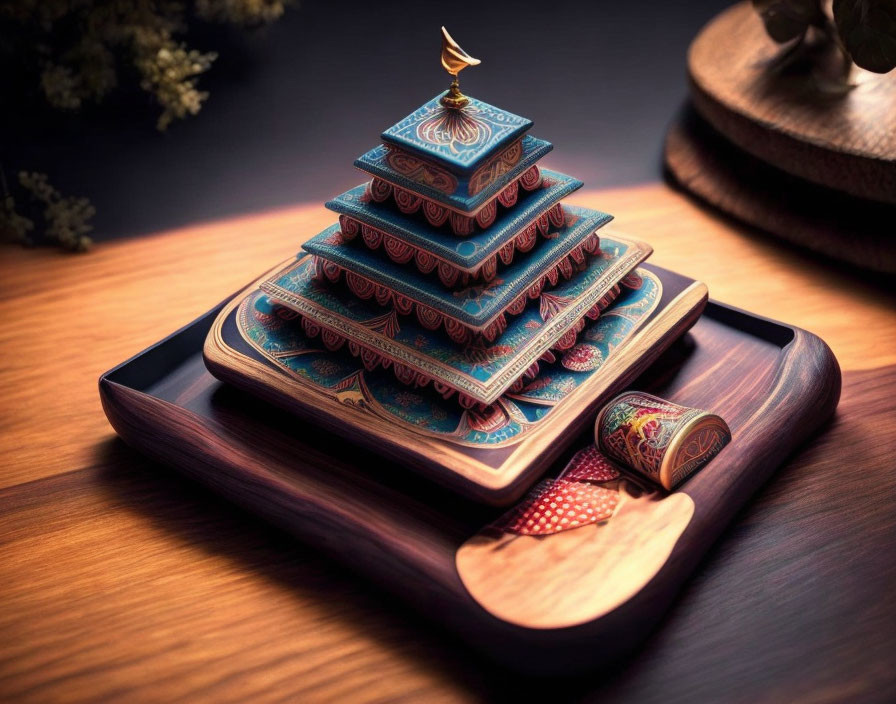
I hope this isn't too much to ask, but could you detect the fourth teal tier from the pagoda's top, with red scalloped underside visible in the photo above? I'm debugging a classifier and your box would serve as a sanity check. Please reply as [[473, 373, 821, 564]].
[[303, 206, 626, 339]]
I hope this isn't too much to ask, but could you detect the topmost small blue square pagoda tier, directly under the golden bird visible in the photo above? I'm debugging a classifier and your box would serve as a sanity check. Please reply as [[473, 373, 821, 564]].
[[382, 93, 533, 175]]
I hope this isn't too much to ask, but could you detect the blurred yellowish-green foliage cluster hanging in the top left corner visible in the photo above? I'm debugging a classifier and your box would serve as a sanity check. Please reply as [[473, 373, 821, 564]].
[[0, 0, 290, 130]]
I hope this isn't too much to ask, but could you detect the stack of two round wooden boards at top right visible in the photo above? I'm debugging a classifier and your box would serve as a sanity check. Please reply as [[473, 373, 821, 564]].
[[665, 2, 896, 274]]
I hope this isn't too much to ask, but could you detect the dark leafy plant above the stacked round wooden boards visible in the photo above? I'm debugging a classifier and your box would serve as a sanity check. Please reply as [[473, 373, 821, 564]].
[[753, 0, 896, 73]]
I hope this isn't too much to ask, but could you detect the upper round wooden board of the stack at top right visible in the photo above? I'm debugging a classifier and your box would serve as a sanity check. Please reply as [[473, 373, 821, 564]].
[[688, 2, 896, 203]]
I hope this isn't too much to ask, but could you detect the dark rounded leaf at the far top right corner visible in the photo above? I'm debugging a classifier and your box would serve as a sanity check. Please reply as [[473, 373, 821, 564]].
[[834, 0, 896, 73]]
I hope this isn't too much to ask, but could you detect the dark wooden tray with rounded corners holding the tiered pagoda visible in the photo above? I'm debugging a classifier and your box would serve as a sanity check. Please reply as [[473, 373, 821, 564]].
[[100, 268, 840, 672]]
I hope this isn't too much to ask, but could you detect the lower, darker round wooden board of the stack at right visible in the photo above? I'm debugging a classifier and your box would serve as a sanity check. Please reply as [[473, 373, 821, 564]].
[[664, 109, 896, 274]]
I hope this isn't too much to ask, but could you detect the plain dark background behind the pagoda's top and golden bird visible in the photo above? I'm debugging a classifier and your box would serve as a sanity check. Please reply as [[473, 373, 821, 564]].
[[0, 0, 729, 239]]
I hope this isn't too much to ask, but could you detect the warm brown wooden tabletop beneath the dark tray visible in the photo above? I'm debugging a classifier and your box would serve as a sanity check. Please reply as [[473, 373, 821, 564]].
[[0, 184, 896, 702]]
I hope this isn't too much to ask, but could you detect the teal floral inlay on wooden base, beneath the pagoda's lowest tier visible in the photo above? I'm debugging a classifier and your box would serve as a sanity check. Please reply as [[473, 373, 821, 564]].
[[234, 269, 662, 448]]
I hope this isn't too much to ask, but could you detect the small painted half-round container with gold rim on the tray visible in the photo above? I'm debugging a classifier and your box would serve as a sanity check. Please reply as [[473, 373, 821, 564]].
[[594, 391, 731, 490]]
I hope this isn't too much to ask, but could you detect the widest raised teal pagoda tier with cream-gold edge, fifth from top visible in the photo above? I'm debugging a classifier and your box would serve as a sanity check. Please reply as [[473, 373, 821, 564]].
[[262, 238, 651, 405]]
